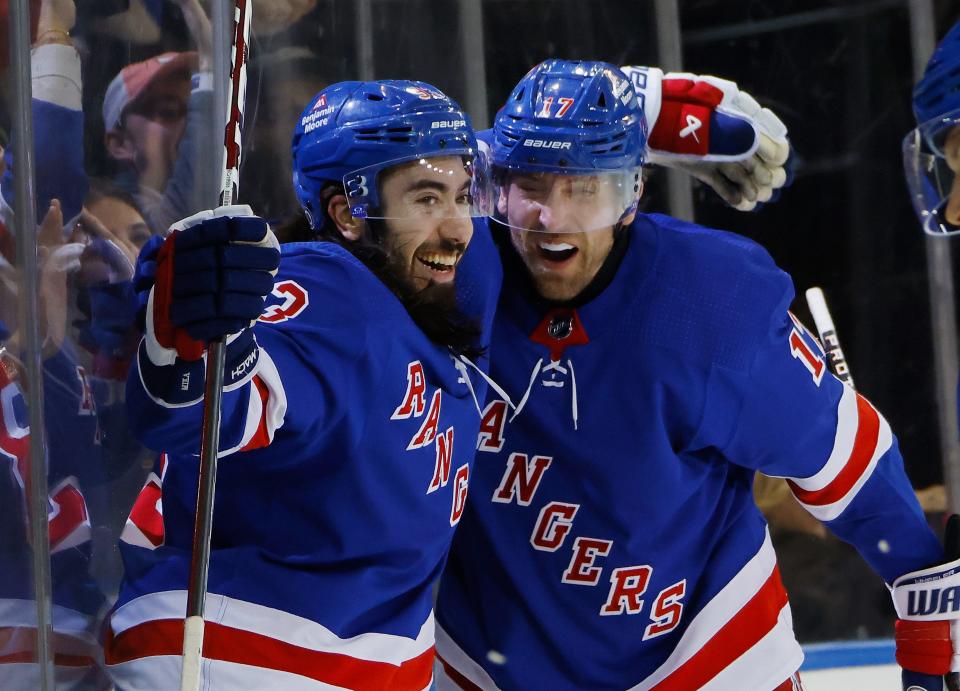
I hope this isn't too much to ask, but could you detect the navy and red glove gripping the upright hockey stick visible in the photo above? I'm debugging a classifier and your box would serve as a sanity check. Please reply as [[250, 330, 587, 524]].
[[146, 205, 280, 364]]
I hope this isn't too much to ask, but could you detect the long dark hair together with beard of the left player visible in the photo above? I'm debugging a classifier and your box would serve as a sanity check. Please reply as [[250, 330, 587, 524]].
[[275, 181, 484, 359]]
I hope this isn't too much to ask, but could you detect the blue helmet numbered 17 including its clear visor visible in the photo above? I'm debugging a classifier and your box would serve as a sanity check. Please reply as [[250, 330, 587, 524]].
[[490, 60, 647, 234]]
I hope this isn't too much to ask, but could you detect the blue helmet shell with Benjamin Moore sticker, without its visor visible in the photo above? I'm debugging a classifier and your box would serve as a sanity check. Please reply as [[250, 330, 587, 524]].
[[291, 80, 489, 230]]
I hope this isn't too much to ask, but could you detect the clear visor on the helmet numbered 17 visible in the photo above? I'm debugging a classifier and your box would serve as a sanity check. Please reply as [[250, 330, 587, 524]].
[[493, 169, 640, 233]]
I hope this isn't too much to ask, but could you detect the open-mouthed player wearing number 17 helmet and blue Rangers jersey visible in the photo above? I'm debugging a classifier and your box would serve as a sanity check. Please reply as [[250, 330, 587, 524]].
[[437, 61, 952, 691]]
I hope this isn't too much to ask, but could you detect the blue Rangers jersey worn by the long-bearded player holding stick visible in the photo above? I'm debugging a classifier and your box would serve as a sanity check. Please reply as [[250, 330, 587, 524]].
[[105, 224, 500, 691]]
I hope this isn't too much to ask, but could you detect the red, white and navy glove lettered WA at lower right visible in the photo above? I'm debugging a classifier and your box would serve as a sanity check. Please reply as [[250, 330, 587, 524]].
[[890, 514, 960, 691]]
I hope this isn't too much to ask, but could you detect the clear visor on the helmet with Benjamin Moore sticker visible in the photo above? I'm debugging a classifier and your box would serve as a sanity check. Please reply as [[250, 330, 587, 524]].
[[343, 152, 493, 219]]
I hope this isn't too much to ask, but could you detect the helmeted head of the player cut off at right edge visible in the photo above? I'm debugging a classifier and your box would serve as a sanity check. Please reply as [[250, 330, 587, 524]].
[[903, 22, 960, 235]]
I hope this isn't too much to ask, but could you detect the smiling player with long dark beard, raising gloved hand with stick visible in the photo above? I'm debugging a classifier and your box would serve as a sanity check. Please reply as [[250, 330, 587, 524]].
[[106, 81, 500, 691]]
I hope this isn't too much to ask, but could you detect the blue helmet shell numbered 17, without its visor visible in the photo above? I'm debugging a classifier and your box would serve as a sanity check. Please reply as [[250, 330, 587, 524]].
[[491, 60, 647, 173]]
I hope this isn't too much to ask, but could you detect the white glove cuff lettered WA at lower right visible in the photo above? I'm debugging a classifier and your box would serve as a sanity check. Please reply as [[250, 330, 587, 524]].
[[890, 559, 960, 628]]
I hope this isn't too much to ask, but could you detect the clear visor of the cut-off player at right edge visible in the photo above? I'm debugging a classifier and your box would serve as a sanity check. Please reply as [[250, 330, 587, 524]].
[[903, 110, 960, 235]]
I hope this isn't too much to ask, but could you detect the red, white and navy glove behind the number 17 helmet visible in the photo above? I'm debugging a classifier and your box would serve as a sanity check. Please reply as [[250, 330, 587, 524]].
[[622, 67, 790, 211]]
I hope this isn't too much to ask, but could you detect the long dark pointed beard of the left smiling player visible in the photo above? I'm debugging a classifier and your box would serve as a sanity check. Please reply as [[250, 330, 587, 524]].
[[348, 219, 483, 359]]
